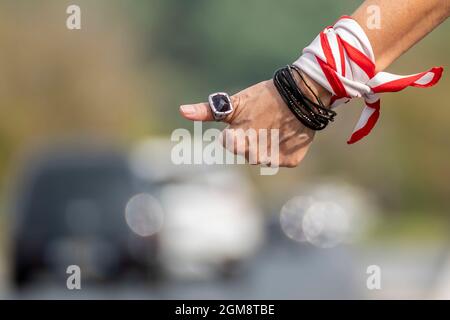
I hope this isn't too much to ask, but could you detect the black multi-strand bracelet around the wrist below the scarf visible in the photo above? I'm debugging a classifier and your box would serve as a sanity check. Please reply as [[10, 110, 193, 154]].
[[273, 65, 336, 130]]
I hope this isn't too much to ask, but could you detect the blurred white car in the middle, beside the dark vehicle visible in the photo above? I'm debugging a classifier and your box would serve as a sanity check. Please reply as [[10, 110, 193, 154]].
[[130, 138, 265, 280]]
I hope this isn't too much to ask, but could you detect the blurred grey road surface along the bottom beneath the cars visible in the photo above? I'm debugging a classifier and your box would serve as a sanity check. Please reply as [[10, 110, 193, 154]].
[[0, 226, 439, 299]]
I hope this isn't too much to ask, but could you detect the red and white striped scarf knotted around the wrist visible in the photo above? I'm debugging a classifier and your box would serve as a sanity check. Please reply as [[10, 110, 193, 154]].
[[294, 16, 443, 144]]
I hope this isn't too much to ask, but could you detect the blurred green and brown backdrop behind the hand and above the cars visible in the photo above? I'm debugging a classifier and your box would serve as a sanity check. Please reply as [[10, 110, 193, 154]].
[[0, 0, 450, 300]]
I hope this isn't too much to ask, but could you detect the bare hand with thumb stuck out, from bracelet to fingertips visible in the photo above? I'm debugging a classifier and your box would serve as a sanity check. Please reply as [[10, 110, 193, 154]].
[[180, 74, 330, 167]]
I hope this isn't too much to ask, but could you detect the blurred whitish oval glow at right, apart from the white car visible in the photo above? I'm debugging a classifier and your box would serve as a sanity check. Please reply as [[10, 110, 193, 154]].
[[280, 183, 376, 248]]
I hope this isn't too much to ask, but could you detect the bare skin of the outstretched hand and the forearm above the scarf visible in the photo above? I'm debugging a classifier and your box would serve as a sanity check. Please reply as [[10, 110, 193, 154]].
[[180, 0, 450, 167]]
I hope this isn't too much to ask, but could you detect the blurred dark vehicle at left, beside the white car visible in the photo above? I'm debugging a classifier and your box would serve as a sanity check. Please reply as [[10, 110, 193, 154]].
[[12, 147, 158, 287]]
